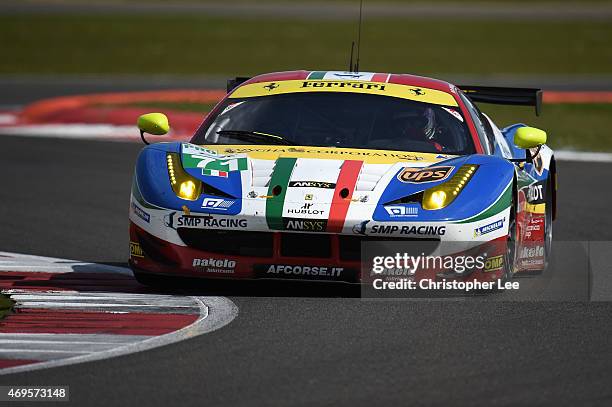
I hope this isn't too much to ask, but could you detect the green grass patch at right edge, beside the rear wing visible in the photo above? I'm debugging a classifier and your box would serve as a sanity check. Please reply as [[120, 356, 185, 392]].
[[480, 104, 612, 151]]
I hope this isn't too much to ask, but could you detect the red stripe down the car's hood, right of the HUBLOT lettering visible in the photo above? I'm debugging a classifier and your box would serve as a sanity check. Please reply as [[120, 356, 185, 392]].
[[327, 160, 363, 233]]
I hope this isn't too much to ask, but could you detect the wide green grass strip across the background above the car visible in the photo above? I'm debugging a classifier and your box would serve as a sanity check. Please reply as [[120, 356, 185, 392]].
[[0, 15, 612, 75]]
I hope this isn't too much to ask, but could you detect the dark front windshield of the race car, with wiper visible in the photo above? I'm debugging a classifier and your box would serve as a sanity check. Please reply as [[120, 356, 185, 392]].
[[192, 92, 474, 154]]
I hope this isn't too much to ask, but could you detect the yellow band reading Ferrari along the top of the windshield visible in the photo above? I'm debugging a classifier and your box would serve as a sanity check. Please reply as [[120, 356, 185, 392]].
[[230, 80, 457, 106]]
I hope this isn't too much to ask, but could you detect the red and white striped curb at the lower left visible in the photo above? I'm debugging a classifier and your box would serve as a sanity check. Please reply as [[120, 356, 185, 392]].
[[0, 252, 238, 375]]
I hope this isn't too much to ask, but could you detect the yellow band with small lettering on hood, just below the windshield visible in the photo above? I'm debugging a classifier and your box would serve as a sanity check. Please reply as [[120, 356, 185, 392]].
[[202, 144, 452, 164]]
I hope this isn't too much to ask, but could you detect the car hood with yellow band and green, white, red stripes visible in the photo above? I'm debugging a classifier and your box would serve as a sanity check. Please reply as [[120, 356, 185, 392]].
[[181, 143, 464, 204]]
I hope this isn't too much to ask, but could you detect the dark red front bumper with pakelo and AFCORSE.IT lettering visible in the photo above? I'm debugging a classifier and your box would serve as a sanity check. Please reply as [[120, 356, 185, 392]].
[[129, 222, 505, 283]]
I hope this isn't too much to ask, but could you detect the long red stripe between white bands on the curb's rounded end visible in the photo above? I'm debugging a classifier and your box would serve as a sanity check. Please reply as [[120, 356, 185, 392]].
[[0, 309, 198, 336]]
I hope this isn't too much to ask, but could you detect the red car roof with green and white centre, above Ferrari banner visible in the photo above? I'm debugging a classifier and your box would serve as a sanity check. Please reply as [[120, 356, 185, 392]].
[[243, 70, 455, 93]]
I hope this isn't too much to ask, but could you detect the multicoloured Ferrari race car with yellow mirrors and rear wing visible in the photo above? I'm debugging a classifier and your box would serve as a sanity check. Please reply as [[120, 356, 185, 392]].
[[129, 71, 556, 285]]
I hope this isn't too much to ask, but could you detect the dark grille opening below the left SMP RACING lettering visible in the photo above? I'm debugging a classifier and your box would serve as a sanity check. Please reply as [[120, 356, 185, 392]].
[[177, 228, 274, 257]]
